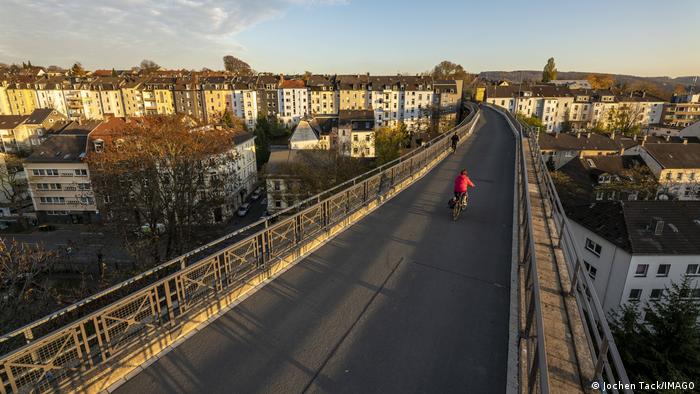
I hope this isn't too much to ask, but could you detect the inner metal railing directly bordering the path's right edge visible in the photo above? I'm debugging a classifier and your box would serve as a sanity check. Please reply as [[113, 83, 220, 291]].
[[490, 107, 549, 394]]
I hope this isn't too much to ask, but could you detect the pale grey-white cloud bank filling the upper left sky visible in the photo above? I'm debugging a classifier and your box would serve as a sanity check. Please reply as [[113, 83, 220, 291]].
[[0, 0, 345, 67]]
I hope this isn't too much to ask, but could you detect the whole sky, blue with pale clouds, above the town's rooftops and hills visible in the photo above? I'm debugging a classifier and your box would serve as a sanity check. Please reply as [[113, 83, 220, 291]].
[[0, 0, 700, 77]]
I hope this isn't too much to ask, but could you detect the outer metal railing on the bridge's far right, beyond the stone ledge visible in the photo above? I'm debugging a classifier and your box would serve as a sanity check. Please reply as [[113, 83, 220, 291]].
[[494, 105, 631, 393]]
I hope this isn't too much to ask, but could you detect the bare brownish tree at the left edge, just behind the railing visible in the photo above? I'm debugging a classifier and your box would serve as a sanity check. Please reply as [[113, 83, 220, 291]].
[[0, 237, 58, 332]]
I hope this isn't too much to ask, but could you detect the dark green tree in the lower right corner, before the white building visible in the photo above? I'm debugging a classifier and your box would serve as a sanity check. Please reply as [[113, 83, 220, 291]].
[[609, 277, 700, 386]]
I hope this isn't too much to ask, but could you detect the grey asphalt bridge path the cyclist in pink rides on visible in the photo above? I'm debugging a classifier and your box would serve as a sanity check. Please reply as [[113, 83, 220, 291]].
[[117, 111, 514, 393]]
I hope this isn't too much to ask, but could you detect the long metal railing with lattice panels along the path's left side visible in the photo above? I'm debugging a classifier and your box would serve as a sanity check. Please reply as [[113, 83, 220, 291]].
[[0, 108, 478, 394]]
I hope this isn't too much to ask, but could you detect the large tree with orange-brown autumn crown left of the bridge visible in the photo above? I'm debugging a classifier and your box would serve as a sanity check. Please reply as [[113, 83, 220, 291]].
[[88, 116, 239, 263]]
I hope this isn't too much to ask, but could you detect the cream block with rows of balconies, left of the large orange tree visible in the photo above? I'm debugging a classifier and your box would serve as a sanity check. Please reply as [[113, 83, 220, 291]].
[[24, 121, 100, 223]]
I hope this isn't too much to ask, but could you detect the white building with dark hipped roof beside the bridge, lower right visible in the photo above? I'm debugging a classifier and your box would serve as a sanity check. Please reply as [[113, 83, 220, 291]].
[[567, 201, 700, 311]]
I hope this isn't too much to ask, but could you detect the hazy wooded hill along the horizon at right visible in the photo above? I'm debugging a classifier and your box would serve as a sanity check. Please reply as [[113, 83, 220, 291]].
[[479, 70, 700, 98]]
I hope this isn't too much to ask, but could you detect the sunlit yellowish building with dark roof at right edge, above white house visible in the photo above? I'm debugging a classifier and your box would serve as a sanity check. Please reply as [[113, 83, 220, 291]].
[[639, 139, 700, 200]]
